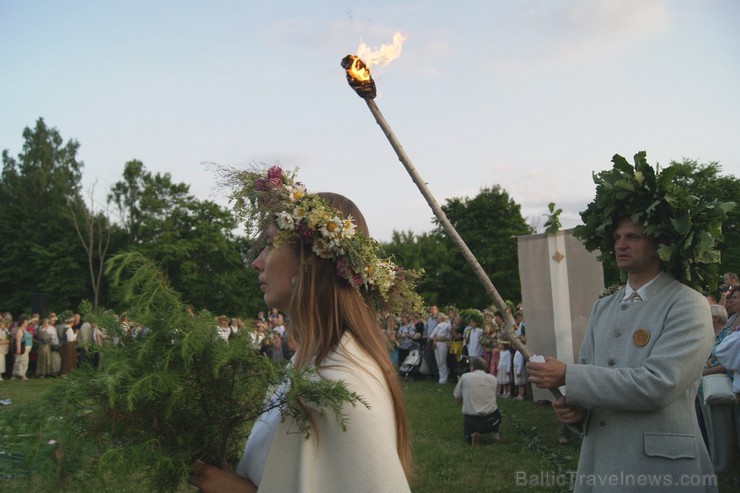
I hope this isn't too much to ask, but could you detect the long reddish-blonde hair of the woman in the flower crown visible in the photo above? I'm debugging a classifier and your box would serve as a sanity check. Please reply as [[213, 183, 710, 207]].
[[290, 193, 412, 478]]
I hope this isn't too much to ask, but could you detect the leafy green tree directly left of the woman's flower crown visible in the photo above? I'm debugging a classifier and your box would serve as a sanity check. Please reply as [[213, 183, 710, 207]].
[[108, 160, 263, 315]]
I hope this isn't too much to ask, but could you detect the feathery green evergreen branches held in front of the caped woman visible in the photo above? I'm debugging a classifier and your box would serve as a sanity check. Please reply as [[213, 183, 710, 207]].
[[0, 252, 362, 491]]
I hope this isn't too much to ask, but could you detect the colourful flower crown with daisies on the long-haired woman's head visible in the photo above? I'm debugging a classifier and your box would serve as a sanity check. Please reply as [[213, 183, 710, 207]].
[[231, 166, 423, 313]]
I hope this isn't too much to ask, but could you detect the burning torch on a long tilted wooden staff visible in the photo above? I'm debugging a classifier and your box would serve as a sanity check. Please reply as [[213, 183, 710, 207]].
[[342, 37, 562, 398]]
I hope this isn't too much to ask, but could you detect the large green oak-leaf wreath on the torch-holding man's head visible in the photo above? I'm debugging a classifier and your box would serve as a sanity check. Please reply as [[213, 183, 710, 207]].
[[573, 151, 735, 291]]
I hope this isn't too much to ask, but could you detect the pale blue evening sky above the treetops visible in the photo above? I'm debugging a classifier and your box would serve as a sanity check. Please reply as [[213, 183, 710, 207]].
[[0, 0, 740, 241]]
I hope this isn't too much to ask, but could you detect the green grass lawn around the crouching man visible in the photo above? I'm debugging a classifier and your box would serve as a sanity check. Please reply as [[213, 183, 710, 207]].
[[0, 379, 740, 493]]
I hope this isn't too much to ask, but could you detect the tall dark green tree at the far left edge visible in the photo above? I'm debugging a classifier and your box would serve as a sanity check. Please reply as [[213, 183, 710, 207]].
[[0, 118, 87, 313]]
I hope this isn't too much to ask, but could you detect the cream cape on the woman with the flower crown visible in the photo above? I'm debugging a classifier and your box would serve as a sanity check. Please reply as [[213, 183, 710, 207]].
[[259, 334, 410, 493]]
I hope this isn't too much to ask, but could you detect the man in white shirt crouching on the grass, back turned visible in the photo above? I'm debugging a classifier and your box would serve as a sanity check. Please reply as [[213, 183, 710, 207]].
[[452, 356, 501, 445]]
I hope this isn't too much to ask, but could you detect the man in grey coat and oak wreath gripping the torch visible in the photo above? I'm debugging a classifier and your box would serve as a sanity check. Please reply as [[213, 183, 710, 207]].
[[527, 154, 728, 492]]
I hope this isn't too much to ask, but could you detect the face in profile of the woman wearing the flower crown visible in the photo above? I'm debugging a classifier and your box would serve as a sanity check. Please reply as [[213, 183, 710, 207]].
[[252, 224, 298, 311]]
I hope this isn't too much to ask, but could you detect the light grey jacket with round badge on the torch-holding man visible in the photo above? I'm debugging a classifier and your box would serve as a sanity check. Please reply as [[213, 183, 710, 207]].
[[566, 272, 717, 492]]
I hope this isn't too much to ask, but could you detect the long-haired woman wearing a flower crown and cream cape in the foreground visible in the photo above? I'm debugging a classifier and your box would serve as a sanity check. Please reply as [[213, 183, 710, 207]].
[[191, 167, 421, 492]]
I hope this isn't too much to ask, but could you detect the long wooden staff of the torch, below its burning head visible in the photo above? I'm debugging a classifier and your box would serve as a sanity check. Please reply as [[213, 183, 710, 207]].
[[360, 95, 562, 398]]
